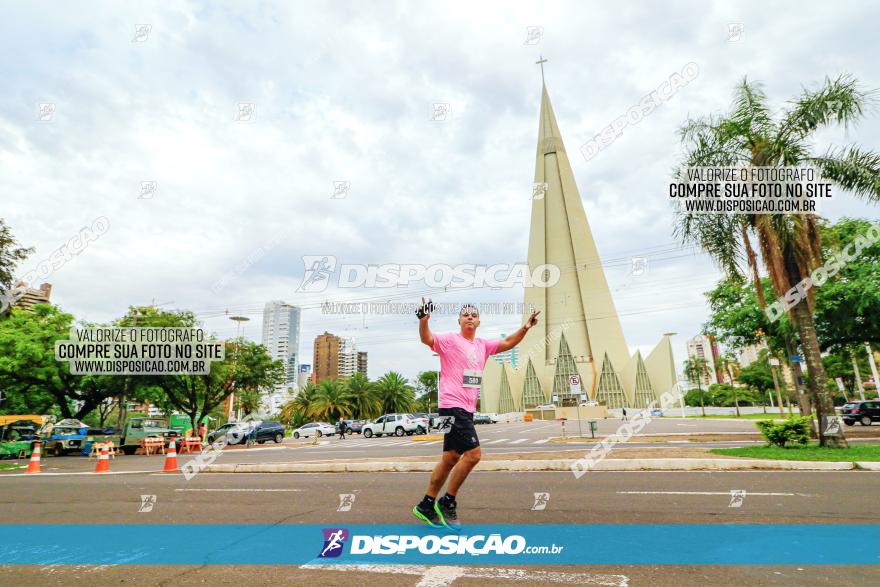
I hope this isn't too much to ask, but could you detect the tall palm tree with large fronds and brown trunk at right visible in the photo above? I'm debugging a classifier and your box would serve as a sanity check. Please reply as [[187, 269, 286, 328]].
[[676, 75, 880, 447]]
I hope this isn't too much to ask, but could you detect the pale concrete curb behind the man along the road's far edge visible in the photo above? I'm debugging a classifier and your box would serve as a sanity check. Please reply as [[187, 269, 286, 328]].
[[204, 459, 852, 473]]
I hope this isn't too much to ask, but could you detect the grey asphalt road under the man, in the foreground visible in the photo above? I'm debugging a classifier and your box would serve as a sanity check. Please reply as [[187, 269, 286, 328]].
[[0, 471, 880, 587]]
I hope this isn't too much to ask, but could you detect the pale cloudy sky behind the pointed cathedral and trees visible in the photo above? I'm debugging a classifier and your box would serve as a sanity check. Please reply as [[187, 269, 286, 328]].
[[0, 0, 880, 377]]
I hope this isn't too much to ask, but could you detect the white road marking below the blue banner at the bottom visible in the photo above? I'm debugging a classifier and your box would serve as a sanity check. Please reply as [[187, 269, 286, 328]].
[[299, 564, 629, 587]]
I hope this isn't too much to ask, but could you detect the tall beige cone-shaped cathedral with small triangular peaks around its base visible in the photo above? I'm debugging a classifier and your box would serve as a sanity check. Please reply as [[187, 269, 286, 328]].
[[480, 83, 676, 413]]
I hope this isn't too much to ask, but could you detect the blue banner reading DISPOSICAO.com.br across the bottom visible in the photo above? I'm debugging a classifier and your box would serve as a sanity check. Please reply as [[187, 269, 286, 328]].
[[0, 524, 880, 565]]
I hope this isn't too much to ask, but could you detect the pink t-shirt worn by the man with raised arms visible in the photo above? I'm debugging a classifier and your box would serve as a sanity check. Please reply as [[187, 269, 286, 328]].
[[433, 332, 501, 413]]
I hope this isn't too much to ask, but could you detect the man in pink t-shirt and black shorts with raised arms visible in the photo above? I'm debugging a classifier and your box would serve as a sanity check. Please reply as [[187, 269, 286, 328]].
[[412, 298, 541, 531]]
